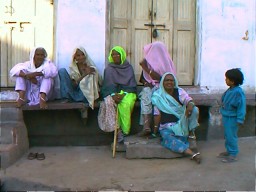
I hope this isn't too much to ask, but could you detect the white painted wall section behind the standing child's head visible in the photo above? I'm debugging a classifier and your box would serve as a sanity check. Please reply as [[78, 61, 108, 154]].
[[198, 0, 256, 91]]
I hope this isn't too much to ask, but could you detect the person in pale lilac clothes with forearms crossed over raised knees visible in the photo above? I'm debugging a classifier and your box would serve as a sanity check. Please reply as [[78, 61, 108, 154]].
[[10, 47, 58, 109]]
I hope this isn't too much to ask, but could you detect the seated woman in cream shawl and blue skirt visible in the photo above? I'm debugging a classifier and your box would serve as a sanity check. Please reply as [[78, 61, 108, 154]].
[[59, 47, 100, 118]]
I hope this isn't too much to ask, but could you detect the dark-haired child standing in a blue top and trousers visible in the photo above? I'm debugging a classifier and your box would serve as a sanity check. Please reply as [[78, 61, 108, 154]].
[[218, 68, 246, 163]]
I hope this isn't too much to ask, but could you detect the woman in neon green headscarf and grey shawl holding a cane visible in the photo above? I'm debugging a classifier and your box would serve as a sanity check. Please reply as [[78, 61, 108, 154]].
[[98, 46, 137, 143]]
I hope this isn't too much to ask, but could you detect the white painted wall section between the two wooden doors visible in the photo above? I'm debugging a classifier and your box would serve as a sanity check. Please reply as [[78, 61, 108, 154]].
[[55, 0, 106, 74]]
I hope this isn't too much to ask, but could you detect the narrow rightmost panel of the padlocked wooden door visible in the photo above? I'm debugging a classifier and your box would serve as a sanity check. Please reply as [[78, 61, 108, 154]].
[[173, 0, 195, 85]]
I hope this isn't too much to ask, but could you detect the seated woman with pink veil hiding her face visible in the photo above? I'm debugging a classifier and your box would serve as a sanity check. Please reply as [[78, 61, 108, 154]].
[[138, 41, 176, 137]]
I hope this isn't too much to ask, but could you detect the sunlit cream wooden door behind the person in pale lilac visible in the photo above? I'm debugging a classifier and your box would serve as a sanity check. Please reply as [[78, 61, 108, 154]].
[[0, 0, 53, 87]]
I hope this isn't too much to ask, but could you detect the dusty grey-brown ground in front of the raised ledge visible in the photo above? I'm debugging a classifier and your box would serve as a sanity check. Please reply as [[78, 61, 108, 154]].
[[1, 137, 255, 191]]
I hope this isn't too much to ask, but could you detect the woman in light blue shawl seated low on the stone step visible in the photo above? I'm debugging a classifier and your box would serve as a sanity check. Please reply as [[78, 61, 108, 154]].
[[152, 72, 201, 164]]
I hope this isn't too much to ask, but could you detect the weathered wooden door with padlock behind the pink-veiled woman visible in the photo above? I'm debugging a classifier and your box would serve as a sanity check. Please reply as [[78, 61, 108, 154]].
[[110, 0, 195, 85]]
